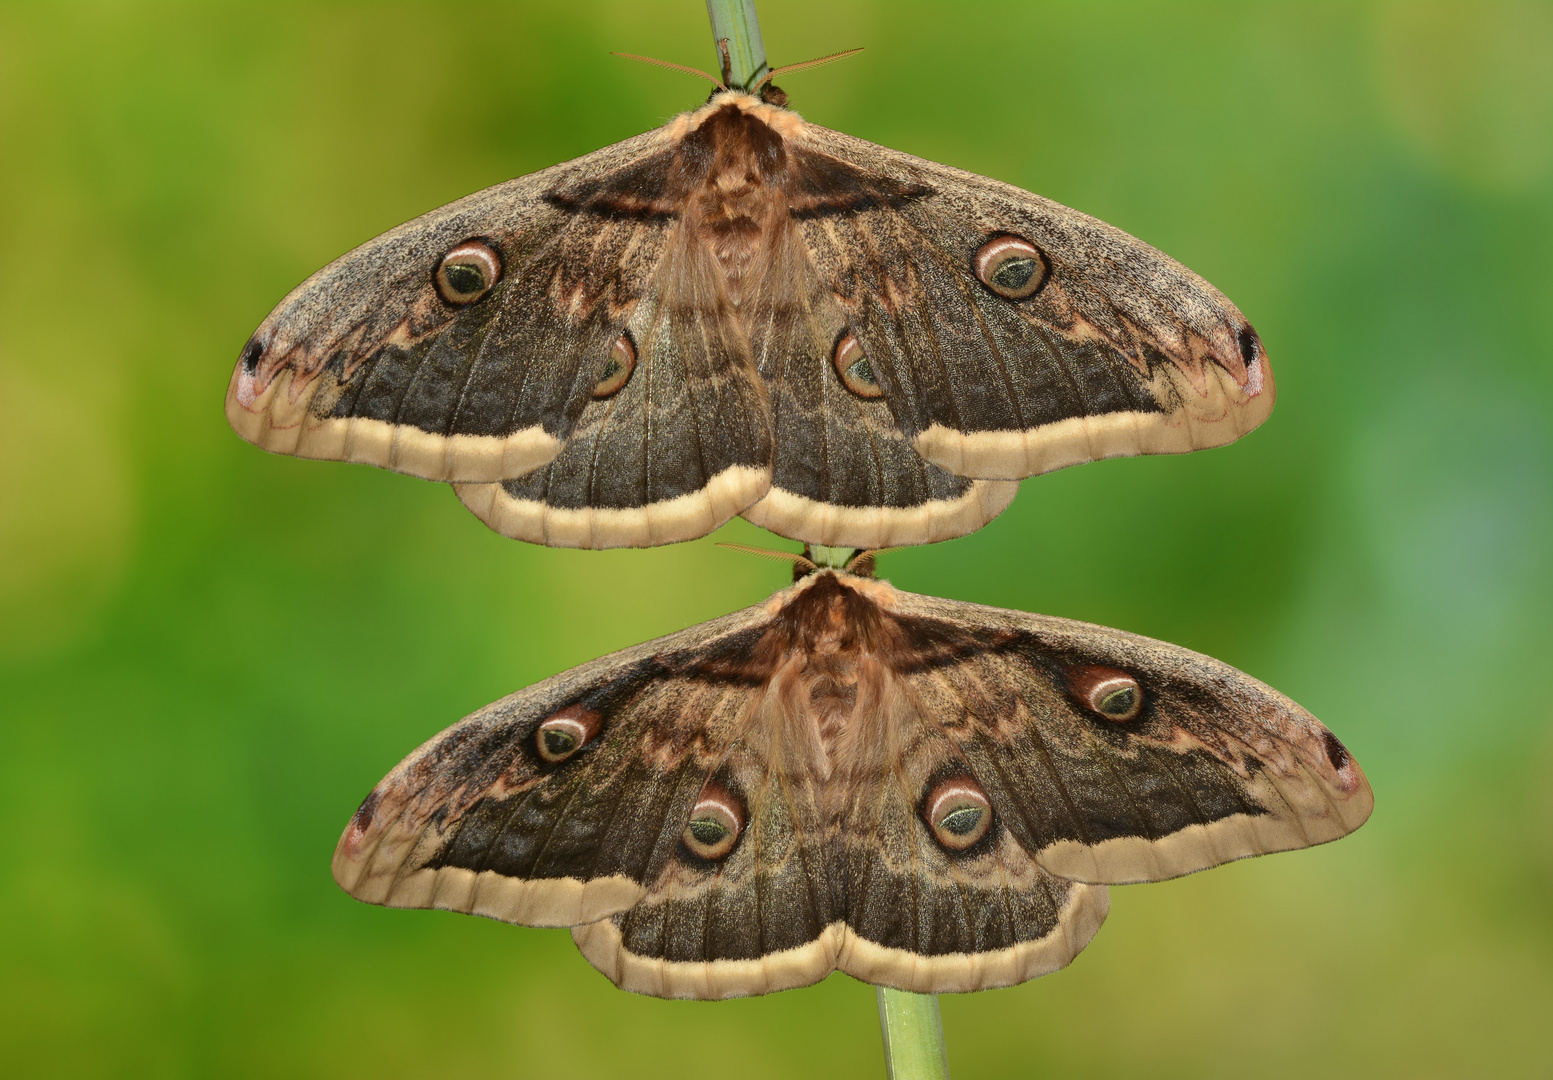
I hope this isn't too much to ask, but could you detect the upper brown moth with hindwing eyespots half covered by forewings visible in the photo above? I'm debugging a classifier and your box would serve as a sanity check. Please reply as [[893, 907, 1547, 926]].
[[227, 85, 1273, 549]]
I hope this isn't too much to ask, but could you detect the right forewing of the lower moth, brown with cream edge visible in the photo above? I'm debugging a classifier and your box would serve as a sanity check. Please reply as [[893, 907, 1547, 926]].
[[882, 595, 1374, 884]]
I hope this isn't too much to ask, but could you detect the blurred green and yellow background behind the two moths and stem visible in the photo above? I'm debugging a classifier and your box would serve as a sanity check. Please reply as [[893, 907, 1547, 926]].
[[0, 0, 1553, 1080]]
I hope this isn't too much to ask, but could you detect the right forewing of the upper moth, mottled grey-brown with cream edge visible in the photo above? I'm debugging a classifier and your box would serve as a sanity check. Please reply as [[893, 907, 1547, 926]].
[[788, 127, 1273, 479]]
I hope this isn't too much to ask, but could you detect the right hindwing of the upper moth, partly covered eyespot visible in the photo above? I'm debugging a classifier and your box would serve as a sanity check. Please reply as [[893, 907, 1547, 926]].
[[744, 230, 1017, 549]]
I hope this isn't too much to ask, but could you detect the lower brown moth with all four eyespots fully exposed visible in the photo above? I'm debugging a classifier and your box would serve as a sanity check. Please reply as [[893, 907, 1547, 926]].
[[334, 553, 1374, 998]]
